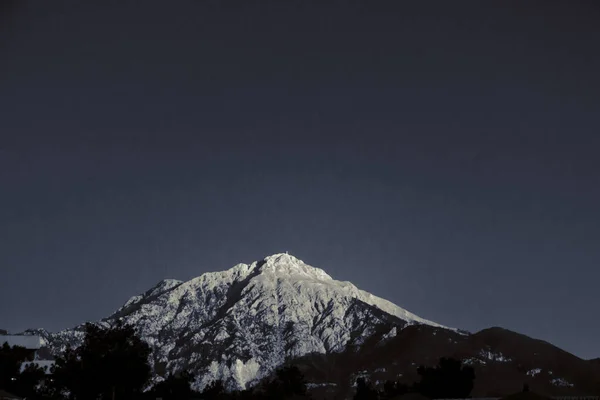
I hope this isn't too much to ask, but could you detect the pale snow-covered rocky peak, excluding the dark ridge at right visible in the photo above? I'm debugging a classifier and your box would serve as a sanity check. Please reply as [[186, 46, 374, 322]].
[[36, 254, 454, 389]]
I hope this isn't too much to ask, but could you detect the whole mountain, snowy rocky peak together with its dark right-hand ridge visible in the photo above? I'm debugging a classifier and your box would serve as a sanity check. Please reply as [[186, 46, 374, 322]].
[[29, 254, 600, 397]]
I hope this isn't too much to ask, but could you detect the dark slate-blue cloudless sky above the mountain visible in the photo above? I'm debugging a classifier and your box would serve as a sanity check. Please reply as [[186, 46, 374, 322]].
[[0, 0, 600, 358]]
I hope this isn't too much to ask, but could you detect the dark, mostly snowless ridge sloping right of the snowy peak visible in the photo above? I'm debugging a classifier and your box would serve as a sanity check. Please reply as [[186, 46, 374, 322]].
[[295, 325, 600, 398]]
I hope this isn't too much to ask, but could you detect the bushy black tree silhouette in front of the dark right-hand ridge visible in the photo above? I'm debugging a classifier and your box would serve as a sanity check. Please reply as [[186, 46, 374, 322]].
[[414, 358, 475, 399]]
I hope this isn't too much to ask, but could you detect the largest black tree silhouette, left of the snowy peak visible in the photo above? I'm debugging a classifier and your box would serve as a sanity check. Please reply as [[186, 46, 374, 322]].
[[53, 321, 151, 400]]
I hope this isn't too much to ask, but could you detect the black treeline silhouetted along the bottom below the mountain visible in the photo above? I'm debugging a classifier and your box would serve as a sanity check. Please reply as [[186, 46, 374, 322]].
[[0, 322, 474, 400]]
